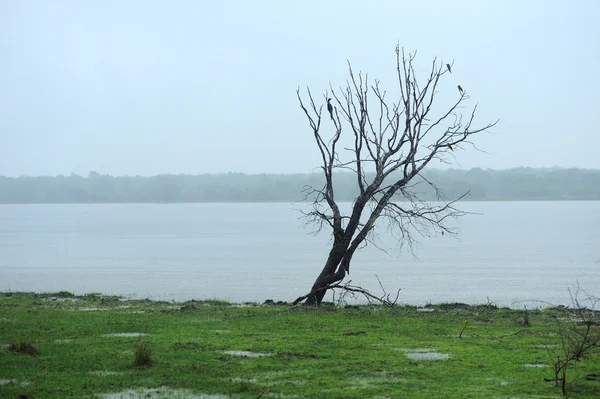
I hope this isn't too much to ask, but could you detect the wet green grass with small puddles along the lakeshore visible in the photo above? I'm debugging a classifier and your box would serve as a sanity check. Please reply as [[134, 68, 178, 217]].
[[0, 292, 600, 399]]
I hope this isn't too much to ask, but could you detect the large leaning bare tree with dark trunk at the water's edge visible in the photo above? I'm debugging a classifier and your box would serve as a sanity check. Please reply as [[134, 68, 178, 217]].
[[294, 46, 497, 305]]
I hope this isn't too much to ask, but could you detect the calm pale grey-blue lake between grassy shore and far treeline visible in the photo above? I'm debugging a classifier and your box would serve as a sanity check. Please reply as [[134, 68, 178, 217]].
[[0, 201, 600, 308]]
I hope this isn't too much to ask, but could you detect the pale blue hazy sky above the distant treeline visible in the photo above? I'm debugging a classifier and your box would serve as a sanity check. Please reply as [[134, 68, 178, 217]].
[[0, 0, 600, 176]]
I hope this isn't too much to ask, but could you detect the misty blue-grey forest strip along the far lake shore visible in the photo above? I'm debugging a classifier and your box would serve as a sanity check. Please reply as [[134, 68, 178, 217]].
[[0, 168, 600, 204]]
